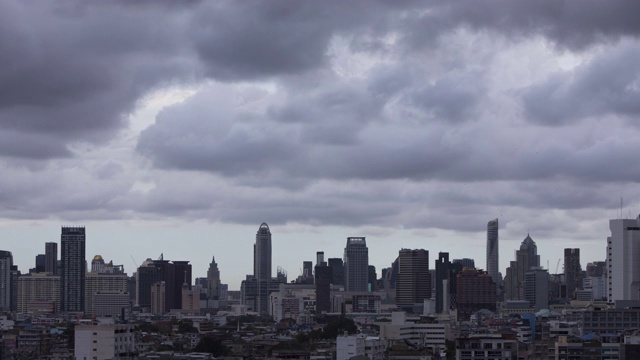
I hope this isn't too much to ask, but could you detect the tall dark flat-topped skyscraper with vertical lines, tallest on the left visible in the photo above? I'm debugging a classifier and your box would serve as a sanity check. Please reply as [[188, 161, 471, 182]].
[[60, 226, 86, 312]]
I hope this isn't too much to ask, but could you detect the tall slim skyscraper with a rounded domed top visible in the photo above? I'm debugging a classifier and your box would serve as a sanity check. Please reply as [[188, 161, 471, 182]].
[[253, 223, 271, 315]]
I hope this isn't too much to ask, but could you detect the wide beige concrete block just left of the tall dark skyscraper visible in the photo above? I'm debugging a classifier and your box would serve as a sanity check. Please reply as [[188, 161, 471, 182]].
[[17, 272, 61, 314]]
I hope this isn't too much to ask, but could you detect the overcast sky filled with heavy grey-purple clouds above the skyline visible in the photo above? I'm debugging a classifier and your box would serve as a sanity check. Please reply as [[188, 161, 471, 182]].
[[0, 0, 640, 289]]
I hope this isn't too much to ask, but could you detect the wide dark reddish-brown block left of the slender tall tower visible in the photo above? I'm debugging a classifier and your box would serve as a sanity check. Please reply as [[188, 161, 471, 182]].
[[456, 269, 496, 321]]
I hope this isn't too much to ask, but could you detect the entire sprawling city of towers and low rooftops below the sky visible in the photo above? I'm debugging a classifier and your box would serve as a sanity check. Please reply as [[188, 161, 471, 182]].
[[0, 216, 640, 359]]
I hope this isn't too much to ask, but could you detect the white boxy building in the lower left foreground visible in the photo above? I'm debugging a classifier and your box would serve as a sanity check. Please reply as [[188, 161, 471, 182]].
[[74, 325, 135, 360]]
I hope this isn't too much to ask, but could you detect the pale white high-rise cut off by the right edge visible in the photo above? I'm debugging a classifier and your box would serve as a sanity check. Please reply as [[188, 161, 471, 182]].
[[607, 216, 640, 303]]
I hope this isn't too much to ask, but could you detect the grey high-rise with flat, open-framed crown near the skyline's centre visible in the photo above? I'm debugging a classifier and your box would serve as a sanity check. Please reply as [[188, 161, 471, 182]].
[[344, 237, 369, 291]]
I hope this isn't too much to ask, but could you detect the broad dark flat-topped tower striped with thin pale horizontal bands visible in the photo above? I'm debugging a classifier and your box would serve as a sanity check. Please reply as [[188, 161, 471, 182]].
[[396, 249, 431, 305]]
